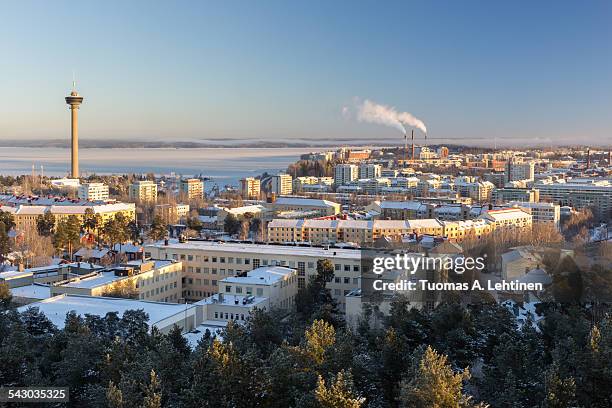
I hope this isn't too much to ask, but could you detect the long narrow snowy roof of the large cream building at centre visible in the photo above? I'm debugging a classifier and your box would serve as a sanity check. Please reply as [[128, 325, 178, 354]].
[[146, 241, 361, 260]]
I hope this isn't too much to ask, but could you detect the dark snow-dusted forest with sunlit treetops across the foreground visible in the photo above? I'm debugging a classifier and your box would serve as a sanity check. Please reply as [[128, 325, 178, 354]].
[[0, 262, 612, 408]]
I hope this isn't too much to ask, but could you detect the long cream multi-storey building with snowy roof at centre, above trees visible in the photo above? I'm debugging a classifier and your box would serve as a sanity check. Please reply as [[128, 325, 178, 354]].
[[145, 240, 361, 305]]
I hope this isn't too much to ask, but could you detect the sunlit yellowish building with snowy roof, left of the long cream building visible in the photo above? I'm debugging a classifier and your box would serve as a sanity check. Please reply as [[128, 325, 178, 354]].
[[51, 260, 182, 303]]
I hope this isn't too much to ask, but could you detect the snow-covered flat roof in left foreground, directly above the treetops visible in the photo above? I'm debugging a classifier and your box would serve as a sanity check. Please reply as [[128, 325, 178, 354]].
[[17, 294, 193, 329]]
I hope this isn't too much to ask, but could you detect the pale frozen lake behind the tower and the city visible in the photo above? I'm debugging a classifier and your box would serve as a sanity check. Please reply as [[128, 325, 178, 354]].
[[0, 147, 328, 186]]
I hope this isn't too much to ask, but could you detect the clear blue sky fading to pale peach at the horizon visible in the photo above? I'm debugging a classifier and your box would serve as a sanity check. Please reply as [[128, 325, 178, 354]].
[[0, 0, 612, 145]]
